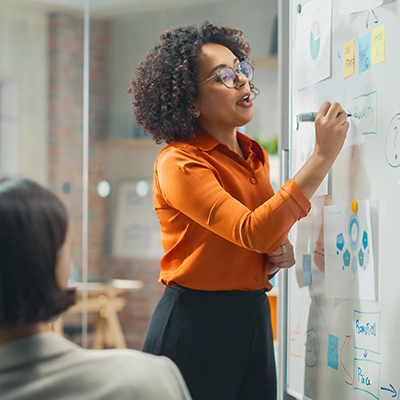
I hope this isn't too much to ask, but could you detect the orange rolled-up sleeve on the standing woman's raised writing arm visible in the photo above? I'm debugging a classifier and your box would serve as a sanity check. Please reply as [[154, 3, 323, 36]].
[[156, 148, 310, 253]]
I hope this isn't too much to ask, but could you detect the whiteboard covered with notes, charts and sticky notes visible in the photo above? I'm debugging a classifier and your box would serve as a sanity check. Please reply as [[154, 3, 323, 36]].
[[285, 0, 400, 400]]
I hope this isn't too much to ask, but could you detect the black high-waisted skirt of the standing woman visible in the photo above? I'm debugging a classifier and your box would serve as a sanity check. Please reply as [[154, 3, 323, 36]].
[[143, 286, 276, 400]]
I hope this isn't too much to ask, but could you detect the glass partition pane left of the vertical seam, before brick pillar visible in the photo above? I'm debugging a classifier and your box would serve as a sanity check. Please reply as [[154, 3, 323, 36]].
[[0, 0, 84, 343]]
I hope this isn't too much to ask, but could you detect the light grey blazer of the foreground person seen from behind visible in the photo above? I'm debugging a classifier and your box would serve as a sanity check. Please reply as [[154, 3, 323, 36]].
[[0, 332, 191, 400]]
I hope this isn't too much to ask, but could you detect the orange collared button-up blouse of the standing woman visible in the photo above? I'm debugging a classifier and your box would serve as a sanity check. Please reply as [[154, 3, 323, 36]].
[[153, 130, 310, 291]]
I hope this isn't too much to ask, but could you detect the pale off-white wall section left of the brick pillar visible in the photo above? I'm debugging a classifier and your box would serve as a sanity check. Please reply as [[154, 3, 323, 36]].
[[0, 3, 48, 184]]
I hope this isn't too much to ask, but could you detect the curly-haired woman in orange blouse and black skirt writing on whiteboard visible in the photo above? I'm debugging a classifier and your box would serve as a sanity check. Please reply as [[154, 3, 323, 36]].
[[128, 23, 348, 400]]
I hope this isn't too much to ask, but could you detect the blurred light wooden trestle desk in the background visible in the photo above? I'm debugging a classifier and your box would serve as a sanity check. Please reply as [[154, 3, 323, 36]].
[[53, 279, 143, 349]]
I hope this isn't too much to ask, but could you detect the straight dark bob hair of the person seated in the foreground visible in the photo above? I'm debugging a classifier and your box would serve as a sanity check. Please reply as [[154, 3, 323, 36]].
[[0, 179, 75, 328]]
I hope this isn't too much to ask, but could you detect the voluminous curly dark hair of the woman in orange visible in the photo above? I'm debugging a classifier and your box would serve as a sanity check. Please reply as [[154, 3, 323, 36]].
[[127, 22, 258, 144]]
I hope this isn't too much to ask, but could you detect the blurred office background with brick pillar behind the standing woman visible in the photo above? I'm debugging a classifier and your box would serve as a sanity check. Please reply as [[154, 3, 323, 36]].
[[0, 0, 279, 349]]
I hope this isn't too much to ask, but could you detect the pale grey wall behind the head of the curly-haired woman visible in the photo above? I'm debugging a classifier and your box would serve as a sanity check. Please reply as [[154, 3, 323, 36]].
[[110, 0, 278, 139]]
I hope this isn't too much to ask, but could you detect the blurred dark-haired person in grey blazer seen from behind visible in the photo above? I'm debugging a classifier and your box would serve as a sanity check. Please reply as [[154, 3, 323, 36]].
[[0, 179, 190, 400]]
